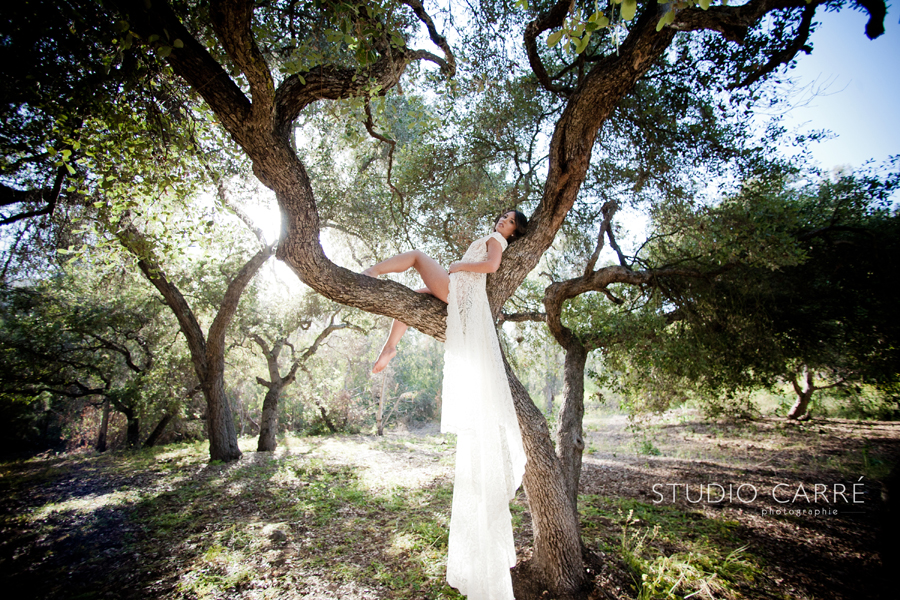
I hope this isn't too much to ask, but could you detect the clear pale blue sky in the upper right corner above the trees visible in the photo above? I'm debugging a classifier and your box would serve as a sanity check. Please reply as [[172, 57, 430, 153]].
[[772, 5, 900, 169]]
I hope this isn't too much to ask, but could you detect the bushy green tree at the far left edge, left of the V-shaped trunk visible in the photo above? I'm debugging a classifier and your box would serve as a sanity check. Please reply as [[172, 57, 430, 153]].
[[0, 268, 191, 451]]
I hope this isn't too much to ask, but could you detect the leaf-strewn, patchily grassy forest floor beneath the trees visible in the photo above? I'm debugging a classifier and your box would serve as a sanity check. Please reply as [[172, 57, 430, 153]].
[[0, 411, 900, 600]]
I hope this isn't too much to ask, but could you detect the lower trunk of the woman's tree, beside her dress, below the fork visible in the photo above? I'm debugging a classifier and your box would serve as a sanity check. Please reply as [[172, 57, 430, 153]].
[[506, 356, 586, 596]]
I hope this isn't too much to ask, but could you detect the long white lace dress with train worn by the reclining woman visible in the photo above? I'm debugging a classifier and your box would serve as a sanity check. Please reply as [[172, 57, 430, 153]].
[[441, 232, 525, 600]]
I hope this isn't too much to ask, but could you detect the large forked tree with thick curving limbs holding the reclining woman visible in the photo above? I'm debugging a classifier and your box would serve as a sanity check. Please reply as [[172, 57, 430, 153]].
[[24, 0, 884, 594]]
